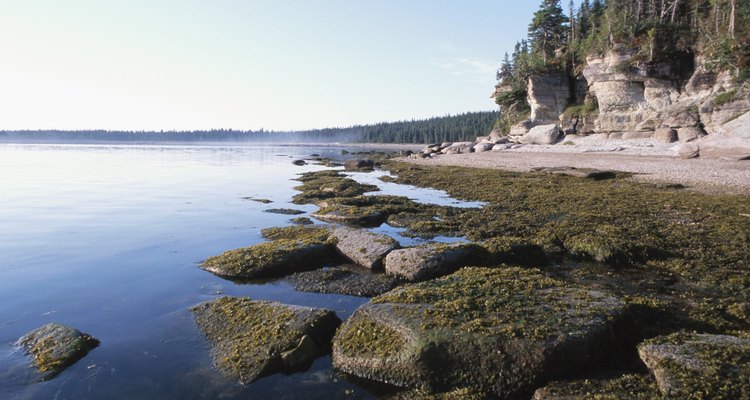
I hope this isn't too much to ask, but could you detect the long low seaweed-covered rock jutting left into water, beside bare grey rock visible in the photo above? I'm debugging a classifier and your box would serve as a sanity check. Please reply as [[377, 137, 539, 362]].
[[201, 230, 335, 279]]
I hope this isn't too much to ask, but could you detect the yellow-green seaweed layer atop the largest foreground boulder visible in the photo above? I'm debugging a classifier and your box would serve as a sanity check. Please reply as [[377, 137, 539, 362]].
[[371, 267, 624, 340]]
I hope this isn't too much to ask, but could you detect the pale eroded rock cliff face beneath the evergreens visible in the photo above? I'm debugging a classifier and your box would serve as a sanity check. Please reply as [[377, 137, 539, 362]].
[[500, 46, 750, 159]]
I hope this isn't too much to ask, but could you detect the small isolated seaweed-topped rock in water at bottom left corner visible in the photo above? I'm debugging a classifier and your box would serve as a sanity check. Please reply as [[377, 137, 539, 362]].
[[16, 323, 99, 380]]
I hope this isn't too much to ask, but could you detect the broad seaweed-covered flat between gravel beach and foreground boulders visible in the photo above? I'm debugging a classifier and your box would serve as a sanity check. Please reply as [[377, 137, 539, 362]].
[[386, 162, 750, 335]]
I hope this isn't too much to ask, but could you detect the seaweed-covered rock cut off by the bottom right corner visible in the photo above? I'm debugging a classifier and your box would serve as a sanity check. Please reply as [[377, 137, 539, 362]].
[[638, 333, 750, 399]]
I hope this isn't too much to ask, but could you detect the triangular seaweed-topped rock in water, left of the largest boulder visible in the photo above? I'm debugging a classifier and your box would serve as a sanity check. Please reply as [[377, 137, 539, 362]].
[[191, 297, 341, 384]]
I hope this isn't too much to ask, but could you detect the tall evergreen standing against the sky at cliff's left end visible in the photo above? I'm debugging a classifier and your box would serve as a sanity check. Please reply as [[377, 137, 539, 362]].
[[529, 0, 568, 64]]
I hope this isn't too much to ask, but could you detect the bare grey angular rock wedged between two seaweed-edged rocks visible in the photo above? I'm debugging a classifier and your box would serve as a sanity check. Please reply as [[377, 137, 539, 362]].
[[331, 226, 400, 269]]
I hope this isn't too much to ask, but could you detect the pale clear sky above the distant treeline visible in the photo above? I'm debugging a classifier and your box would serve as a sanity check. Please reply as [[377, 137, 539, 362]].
[[0, 0, 567, 130]]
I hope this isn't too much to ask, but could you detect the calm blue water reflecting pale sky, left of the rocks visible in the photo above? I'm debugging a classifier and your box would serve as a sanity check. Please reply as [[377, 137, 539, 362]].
[[0, 145, 476, 399]]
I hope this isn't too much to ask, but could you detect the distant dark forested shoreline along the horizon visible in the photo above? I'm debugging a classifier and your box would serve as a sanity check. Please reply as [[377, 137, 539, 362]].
[[0, 111, 497, 143]]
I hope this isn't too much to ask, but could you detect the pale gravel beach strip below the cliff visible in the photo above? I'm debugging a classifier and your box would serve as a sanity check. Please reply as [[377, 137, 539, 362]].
[[406, 136, 750, 195]]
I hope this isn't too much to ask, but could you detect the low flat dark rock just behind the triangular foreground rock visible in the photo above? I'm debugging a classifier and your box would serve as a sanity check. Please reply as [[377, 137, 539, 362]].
[[289, 265, 406, 297]]
